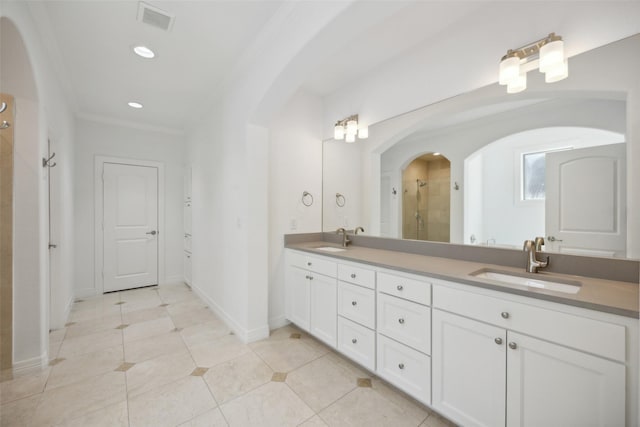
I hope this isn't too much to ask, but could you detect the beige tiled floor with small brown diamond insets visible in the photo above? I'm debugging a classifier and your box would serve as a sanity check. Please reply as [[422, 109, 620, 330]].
[[0, 285, 452, 427]]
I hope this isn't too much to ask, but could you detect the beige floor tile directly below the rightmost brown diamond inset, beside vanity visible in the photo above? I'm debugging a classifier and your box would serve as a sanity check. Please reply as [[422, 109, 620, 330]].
[[318, 387, 426, 427]]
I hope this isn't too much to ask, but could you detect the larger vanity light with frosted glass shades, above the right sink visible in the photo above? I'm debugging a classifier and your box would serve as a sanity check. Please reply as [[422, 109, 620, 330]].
[[498, 33, 569, 93]]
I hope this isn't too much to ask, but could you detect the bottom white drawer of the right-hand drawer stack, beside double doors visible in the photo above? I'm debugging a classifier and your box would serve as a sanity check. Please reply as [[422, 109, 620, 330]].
[[376, 334, 431, 405]]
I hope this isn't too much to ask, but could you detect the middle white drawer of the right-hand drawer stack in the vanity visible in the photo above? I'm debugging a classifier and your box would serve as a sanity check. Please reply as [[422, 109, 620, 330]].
[[378, 294, 431, 354]]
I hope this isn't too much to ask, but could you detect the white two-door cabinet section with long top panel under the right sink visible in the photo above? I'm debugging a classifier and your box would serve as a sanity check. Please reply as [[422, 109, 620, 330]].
[[432, 284, 626, 426]]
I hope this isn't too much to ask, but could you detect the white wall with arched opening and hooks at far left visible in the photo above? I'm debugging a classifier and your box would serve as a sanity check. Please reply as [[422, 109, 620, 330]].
[[0, 2, 74, 370]]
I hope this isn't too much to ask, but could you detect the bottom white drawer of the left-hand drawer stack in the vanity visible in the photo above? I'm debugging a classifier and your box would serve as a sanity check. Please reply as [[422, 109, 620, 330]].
[[338, 316, 376, 371]]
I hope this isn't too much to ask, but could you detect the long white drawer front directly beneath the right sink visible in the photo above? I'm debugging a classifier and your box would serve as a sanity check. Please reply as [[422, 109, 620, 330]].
[[433, 285, 626, 362]]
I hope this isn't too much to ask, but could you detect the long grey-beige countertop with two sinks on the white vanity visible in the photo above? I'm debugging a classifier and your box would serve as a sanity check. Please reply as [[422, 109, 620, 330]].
[[286, 241, 640, 319]]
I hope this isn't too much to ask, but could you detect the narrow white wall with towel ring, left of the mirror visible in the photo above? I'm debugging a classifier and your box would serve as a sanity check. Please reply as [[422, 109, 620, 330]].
[[269, 91, 322, 329]]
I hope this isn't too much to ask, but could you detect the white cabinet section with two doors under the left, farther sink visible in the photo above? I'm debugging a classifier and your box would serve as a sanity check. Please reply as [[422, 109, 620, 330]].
[[285, 251, 338, 348]]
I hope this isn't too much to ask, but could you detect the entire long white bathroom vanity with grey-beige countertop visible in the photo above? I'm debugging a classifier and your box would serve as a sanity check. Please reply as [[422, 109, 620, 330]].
[[285, 240, 639, 426]]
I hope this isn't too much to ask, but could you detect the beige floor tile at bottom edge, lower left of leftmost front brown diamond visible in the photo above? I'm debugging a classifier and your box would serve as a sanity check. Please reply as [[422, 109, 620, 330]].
[[33, 372, 127, 426]]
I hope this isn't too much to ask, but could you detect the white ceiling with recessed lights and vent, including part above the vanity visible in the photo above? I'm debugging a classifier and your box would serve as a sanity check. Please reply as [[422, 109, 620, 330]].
[[30, 0, 640, 135]]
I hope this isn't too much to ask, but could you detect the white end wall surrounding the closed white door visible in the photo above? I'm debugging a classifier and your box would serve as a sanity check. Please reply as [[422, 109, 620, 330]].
[[74, 118, 184, 296]]
